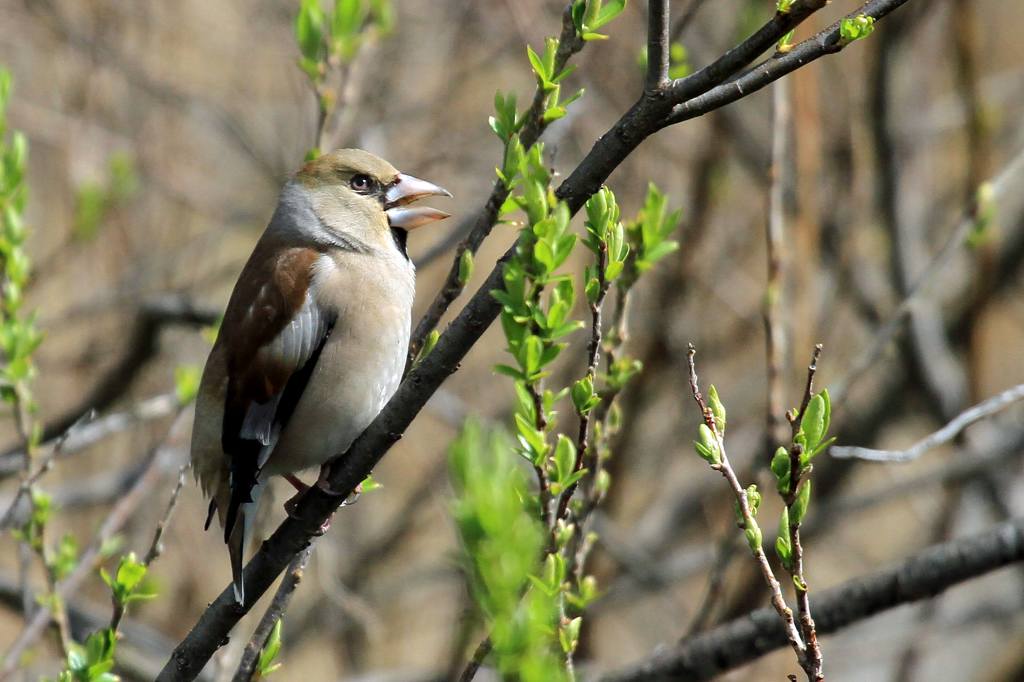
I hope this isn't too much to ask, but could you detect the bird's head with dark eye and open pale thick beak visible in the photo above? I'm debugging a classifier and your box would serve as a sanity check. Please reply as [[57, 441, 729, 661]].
[[296, 150, 452, 248]]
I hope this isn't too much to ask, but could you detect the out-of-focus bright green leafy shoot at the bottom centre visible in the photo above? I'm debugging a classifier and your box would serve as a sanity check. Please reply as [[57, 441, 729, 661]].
[[449, 421, 567, 682]]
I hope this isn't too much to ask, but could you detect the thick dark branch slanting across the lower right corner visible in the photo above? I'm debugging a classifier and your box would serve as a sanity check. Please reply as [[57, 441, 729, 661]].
[[600, 519, 1024, 682]]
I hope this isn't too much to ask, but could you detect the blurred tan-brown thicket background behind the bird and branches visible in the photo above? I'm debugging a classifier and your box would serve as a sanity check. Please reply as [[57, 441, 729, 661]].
[[0, 0, 1024, 680]]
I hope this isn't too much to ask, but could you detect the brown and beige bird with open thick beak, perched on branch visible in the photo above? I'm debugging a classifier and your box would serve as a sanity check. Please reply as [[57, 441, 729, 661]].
[[191, 150, 452, 603]]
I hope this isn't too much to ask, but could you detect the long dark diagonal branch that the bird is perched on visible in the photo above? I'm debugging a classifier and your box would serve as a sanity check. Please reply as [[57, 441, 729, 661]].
[[159, 0, 921, 680]]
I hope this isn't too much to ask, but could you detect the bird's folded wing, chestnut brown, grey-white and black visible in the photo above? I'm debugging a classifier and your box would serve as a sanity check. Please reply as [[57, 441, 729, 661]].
[[218, 242, 335, 540]]
